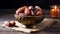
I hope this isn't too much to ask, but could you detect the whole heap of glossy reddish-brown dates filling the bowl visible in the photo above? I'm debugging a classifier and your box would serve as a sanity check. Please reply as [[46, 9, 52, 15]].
[[16, 6, 43, 16]]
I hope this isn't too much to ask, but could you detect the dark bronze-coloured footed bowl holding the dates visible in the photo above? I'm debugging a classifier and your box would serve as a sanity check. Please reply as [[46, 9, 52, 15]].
[[14, 14, 44, 27]]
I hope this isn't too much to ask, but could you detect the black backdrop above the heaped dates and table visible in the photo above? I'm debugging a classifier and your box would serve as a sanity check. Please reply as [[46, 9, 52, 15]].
[[0, 0, 60, 9]]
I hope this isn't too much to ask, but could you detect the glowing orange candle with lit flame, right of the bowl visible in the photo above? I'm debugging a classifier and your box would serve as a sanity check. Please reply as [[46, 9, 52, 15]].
[[50, 5, 60, 18]]
